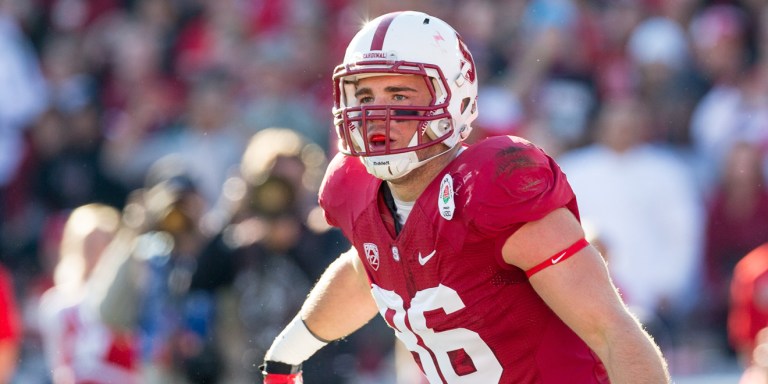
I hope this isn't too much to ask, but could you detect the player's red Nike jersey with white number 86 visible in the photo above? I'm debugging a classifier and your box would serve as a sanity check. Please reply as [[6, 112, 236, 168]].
[[320, 136, 608, 384]]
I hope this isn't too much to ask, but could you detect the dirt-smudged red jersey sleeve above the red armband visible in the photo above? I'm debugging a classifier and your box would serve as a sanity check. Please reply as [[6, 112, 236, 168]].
[[472, 138, 578, 236]]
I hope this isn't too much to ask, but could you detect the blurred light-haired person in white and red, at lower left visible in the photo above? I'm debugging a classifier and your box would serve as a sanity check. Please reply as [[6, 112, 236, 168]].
[[39, 204, 139, 384]]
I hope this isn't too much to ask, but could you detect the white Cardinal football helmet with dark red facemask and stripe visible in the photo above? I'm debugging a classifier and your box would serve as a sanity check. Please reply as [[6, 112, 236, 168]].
[[333, 11, 477, 180]]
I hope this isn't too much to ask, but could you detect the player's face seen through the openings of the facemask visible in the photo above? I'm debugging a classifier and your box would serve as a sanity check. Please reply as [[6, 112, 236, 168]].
[[355, 75, 432, 151]]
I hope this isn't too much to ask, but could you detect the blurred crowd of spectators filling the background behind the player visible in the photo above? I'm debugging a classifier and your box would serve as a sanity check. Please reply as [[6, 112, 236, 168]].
[[0, 0, 768, 384]]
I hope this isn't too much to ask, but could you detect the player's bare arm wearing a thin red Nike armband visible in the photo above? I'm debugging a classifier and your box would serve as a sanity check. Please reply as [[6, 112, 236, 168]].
[[502, 208, 670, 384]]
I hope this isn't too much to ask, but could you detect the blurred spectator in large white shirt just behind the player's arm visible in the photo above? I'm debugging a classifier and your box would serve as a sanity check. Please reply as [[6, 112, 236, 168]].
[[558, 98, 703, 356]]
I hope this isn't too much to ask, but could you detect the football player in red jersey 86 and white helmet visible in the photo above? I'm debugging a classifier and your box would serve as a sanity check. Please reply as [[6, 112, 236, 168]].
[[262, 11, 670, 384]]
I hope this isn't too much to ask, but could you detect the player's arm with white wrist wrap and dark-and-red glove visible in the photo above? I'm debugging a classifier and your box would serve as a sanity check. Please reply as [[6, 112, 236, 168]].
[[263, 247, 378, 384]]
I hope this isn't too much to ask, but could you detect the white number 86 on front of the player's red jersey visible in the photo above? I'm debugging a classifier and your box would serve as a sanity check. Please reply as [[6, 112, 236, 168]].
[[372, 284, 502, 384]]
